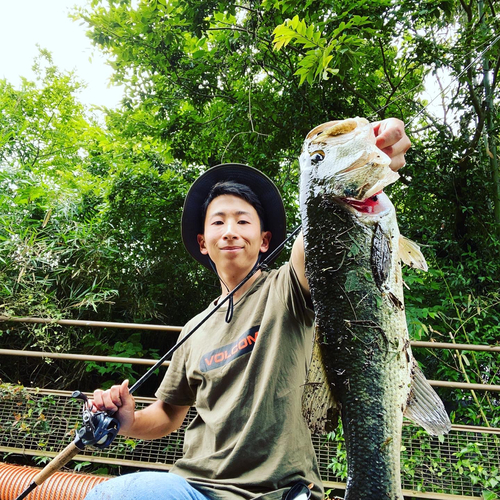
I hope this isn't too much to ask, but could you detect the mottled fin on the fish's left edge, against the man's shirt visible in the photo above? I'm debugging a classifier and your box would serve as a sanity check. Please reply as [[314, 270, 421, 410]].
[[302, 340, 339, 433]]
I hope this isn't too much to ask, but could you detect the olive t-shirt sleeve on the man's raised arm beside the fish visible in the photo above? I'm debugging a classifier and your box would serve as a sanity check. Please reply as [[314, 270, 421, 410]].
[[276, 262, 314, 326]]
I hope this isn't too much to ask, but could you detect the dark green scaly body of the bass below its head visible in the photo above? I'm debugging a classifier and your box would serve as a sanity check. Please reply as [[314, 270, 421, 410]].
[[304, 193, 410, 499]]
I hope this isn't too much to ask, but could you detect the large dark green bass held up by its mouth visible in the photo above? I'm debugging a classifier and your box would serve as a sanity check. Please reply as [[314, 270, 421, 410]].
[[300, 118, 451, 500]]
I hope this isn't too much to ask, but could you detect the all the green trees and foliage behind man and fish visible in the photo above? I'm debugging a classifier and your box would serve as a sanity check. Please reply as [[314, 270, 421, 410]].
[[0, 0, 500, 492]]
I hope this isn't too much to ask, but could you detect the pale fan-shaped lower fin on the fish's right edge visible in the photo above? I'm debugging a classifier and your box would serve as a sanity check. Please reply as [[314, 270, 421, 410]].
[[405, 362, 451, 436]]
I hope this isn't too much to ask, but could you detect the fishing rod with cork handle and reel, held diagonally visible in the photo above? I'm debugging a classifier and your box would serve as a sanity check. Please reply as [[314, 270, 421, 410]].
[[15, 225, 302, 500]]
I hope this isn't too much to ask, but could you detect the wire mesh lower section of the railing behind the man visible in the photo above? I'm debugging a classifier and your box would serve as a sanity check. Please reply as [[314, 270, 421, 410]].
[[0, 389, 500, 500]]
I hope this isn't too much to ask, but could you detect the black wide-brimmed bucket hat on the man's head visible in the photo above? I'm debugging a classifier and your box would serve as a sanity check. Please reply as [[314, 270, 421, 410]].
[[181, 163, 286, 269]]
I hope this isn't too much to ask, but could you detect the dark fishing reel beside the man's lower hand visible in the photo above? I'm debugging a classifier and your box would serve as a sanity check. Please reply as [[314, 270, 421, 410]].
[[71, 391, 120, 450]]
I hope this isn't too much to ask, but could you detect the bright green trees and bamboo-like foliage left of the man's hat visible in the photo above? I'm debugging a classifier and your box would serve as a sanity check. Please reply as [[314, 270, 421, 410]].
[[0, 52, 204, 389]]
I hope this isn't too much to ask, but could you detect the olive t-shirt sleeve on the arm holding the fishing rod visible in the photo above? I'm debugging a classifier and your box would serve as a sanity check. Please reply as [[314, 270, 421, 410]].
[[155, 327, 195, 406]]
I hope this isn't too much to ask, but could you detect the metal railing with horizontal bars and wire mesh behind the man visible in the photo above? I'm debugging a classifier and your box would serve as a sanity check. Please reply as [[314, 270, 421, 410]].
[[0, 316, 500, 500]]
